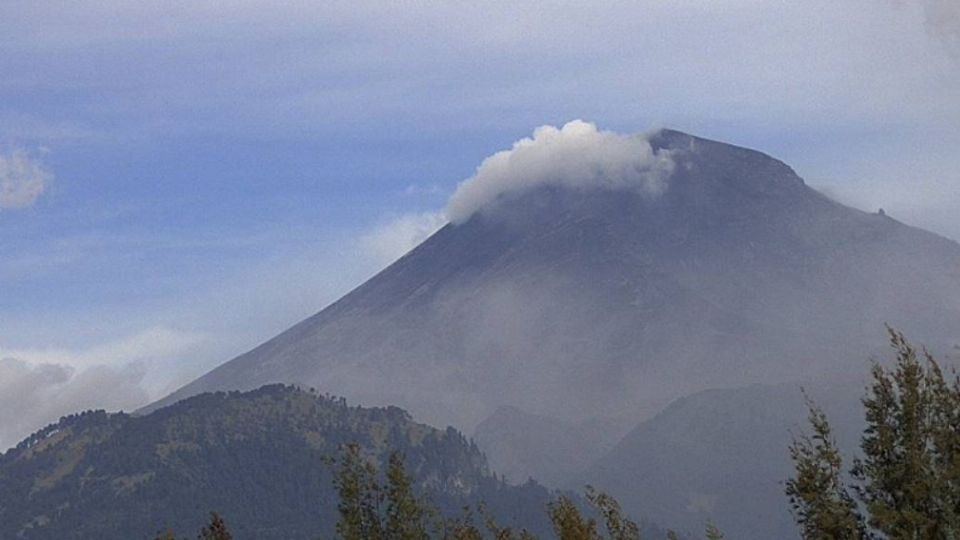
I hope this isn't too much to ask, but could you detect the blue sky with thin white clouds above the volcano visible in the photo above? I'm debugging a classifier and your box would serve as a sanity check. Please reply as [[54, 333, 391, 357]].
[[0, 0, 960, 446]]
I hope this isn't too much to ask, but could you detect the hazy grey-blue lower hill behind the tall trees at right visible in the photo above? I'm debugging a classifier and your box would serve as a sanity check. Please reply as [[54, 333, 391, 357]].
[[578, 380, 864, 540]]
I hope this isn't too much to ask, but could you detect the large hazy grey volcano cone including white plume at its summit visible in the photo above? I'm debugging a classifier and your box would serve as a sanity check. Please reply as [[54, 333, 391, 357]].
[[148, 124, 960, 429]]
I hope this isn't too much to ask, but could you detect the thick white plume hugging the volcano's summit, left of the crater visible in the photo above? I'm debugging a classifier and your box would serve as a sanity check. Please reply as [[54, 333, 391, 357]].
[[447, 120, 673, 223]]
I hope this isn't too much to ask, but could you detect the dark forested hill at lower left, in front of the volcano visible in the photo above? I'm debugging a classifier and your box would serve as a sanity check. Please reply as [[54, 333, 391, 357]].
[[0, 385, 549, 540]]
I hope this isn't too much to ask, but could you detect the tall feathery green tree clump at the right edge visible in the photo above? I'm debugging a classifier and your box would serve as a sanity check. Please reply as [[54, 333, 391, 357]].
[[787, 328, 960, 540]]
